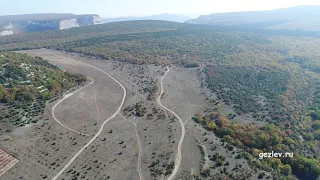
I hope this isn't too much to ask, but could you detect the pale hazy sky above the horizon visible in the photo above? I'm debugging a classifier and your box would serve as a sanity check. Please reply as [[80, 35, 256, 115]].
[[0, 0, 320, 17]]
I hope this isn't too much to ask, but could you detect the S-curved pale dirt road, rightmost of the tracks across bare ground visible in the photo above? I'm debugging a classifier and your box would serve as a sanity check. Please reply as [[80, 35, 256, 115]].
[[157, 66, 185, 180]]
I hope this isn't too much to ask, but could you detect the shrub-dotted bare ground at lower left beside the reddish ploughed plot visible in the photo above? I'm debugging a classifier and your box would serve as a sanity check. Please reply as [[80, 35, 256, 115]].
[[0, 102, 88, 180]]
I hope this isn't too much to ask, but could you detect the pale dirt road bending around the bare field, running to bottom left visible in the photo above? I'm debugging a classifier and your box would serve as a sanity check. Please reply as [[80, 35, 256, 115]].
[[52, 63, 127, 180]]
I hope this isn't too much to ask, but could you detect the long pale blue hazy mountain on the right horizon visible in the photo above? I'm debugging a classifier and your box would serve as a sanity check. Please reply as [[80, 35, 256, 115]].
[[185, 6, 320, 31]]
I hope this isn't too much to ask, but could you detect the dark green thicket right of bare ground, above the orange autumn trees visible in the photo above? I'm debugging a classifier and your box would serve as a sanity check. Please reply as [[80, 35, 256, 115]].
[[205, 67, 290, 121]]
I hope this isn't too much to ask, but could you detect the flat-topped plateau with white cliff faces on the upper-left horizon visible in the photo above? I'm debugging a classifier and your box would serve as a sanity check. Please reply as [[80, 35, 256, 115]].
[[0, 14, 102, 36]]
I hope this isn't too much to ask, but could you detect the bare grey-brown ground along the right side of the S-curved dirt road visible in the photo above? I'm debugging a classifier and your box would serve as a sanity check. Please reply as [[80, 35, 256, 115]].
[[162, 68, 210, 179]]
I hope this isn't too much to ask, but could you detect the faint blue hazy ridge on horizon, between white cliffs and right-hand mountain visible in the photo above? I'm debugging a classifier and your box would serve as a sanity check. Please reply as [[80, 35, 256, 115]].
[[102, 13, 192, 23]]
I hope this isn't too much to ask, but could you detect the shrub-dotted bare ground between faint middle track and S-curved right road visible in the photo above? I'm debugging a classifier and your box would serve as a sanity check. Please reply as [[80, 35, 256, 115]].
[[82, 55, 181, 179]]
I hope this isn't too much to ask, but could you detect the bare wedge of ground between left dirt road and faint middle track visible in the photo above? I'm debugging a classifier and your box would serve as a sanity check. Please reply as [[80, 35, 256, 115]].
[[61, 115, 139, 180]]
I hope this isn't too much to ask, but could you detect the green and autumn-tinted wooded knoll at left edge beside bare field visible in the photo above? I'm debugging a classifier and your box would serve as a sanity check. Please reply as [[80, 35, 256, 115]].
[[0, 52, 86, 126]]
